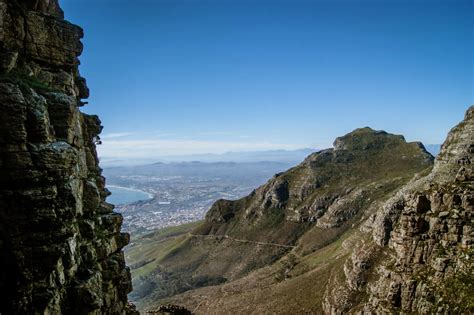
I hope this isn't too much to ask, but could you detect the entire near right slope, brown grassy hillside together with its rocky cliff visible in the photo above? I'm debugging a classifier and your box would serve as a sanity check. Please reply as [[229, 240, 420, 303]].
[[143, 107, 474, 314]]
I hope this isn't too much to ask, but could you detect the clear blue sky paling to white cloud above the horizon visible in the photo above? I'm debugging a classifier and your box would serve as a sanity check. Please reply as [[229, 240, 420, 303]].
[[60, 0, 474, 158]]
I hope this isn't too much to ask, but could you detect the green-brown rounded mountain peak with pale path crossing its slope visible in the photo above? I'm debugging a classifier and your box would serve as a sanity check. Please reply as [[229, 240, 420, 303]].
[[132, 128, 433, 312]]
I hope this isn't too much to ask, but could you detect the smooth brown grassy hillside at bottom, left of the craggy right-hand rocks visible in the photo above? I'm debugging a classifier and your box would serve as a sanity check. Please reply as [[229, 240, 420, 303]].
[[153, 230, 360, 314]]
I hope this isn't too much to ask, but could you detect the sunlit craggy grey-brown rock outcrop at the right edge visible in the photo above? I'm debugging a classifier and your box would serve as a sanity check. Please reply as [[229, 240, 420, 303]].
[[324, 107, 474, 314]]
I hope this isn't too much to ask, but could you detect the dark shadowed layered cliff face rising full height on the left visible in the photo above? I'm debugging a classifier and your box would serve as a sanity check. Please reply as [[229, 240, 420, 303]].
[[0, 0, 133, 314]]
